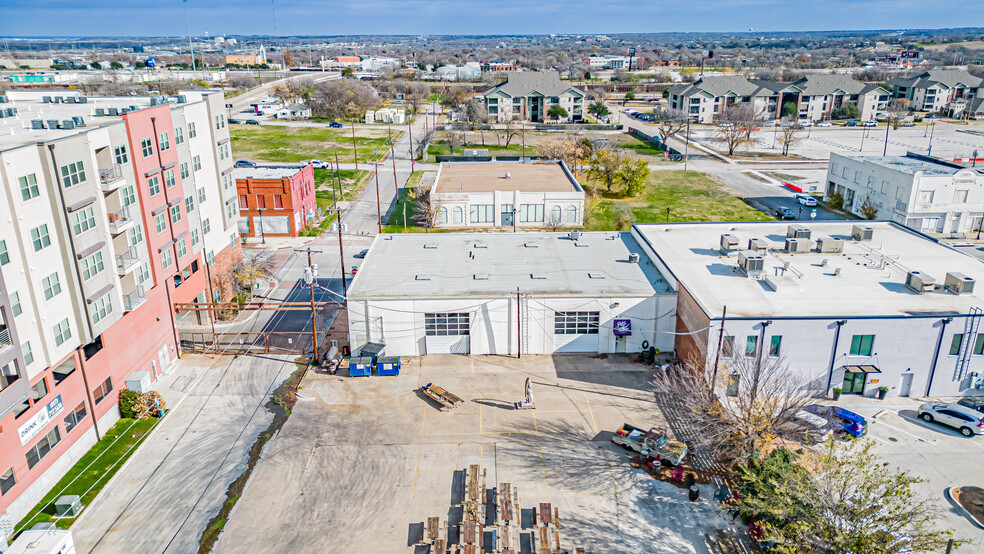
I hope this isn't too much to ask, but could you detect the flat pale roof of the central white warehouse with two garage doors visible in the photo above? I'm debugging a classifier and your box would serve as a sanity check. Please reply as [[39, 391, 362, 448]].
[[348, 232, 672, 300]]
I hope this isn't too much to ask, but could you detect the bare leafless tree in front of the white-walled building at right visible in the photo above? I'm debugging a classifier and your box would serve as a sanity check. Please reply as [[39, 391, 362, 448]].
[[653, 352, 822, 462]]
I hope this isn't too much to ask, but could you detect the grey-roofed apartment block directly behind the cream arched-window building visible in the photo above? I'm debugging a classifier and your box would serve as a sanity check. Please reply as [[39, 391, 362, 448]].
[[482, 71, 586, 123]]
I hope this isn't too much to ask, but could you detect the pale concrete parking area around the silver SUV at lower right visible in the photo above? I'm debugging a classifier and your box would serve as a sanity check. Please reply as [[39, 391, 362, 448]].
[[837, 397, 984, 552]]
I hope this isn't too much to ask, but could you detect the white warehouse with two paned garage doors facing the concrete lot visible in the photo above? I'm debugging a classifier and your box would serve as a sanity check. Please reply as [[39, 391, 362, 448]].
[[347, 231, 676, 356]]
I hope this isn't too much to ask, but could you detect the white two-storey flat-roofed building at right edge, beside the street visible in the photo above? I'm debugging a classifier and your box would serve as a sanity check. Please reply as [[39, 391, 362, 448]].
[[825, 152, 984, 233]]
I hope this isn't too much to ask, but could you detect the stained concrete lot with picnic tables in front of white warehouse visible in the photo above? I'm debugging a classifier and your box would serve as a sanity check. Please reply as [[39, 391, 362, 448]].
[[216, 355, 744, 553]]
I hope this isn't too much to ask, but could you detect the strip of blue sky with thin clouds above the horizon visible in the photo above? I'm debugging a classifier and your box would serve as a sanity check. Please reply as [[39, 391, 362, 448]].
[[0, 0, 984, 36]]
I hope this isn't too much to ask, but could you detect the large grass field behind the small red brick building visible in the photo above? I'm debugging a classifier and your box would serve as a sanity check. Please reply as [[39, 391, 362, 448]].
[[229, 125, 402, 163]]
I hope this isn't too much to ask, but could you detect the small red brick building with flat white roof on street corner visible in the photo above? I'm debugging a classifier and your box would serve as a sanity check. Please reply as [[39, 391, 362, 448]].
[[233, 163, 318, 237]]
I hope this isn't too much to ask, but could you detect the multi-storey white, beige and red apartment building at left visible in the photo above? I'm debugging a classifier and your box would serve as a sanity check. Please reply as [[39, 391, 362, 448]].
[[0, 91, 239, 521]]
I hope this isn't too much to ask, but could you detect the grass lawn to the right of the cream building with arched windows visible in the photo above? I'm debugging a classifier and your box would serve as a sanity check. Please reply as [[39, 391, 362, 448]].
[[584, 171, 772, 231]]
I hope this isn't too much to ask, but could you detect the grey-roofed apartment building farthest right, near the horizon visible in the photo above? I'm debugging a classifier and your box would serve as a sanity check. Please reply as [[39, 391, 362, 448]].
[[888, 69, 984, 112]]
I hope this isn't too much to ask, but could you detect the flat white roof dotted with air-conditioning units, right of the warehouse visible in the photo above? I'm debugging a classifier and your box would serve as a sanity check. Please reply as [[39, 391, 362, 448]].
[[634, 221, 984, 318]]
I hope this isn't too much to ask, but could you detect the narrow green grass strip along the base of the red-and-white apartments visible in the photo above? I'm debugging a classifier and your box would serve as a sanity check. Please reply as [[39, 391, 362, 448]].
[[17, 414, 160, 530]]
